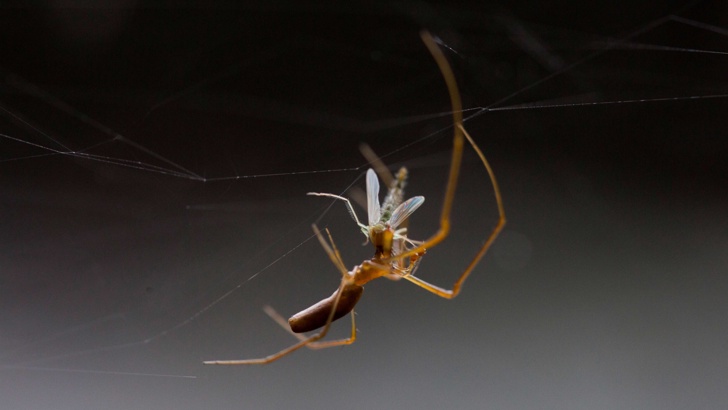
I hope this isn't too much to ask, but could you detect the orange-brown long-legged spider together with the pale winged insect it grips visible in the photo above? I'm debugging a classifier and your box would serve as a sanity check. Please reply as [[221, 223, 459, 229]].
[[204, 31, 506, 365]]
